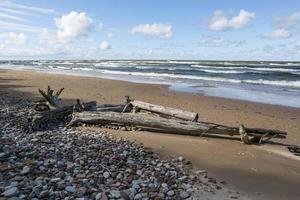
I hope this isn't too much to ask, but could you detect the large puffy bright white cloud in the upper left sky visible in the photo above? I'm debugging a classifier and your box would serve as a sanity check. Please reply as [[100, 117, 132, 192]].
[[54, 11, 92, 40]]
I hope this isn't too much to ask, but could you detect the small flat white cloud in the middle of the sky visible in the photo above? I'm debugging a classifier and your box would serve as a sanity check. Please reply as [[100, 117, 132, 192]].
[[130, 23, 172, 39]]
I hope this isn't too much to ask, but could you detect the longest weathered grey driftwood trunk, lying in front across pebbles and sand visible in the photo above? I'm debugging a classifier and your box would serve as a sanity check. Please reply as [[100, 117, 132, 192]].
[[68, 112, 286, 144]]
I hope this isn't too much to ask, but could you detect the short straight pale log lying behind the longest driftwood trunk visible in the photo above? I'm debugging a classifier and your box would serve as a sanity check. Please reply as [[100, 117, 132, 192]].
[[130, 100, 198, 122]]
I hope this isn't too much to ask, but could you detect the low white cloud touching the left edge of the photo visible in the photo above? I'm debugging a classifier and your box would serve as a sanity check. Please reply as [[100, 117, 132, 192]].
[[0, 32, 28, 45]]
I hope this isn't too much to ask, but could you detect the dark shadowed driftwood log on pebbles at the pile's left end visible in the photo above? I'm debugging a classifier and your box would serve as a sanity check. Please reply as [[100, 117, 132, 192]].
[[29, 101, 96, 130]]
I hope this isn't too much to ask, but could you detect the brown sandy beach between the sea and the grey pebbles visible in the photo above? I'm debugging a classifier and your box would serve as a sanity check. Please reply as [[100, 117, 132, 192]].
[[0, 70, 300, 199]]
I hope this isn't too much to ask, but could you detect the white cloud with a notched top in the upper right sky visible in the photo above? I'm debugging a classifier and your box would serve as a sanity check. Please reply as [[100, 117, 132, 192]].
[[209, 9, 255, 31]]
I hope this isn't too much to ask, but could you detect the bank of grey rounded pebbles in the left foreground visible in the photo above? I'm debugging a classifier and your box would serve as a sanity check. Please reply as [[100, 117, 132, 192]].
[[0, 92, 238, 199]]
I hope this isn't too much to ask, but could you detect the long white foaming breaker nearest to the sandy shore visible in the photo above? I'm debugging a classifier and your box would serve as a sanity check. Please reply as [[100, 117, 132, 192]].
[[101, 70, 300, 88]]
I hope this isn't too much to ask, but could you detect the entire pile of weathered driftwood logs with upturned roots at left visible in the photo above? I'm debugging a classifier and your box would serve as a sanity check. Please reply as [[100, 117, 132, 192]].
[[29, 86, 287, 144]]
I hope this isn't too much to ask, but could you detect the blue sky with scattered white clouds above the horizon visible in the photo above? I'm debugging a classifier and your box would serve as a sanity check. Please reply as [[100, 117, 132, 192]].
[[0, 0, 300, 61]]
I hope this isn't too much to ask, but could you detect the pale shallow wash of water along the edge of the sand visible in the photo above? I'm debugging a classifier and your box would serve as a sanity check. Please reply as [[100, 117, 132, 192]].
[[0, 66, 300, 109]]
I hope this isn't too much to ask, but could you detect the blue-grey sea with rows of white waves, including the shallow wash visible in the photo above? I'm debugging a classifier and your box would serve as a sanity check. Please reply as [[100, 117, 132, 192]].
[[0, 60, 300, 108]]
